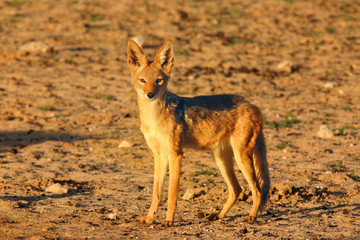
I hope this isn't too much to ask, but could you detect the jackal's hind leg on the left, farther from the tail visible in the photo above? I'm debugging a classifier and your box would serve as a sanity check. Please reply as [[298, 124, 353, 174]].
[[209, 144, 241, 221]]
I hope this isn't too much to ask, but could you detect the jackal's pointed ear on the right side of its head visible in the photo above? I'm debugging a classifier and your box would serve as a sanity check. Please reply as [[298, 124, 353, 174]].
[[154, 40, 174, 75]]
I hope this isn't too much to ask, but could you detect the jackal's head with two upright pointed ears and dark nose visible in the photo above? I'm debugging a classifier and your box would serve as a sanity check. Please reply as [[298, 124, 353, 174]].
[[127, 40, 174, 100]]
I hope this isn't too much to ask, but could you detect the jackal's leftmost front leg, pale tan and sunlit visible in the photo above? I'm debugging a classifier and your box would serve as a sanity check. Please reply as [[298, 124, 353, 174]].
[[139, 152, 168, 224]]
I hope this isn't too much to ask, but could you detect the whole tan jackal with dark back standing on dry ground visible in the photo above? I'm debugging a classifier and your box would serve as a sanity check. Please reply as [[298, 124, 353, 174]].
[[128, 40, 270, 226]]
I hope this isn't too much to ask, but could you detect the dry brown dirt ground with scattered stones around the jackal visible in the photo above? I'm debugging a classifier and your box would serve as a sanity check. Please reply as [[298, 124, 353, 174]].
[[0, 0, 360, 240]]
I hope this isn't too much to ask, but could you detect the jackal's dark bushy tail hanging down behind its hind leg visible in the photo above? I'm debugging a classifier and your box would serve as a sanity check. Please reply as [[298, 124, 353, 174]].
[[253, 132, 270, 213]]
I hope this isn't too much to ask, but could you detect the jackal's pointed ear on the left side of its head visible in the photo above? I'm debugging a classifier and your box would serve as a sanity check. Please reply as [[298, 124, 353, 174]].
[[128, 40, 148, 74]]
